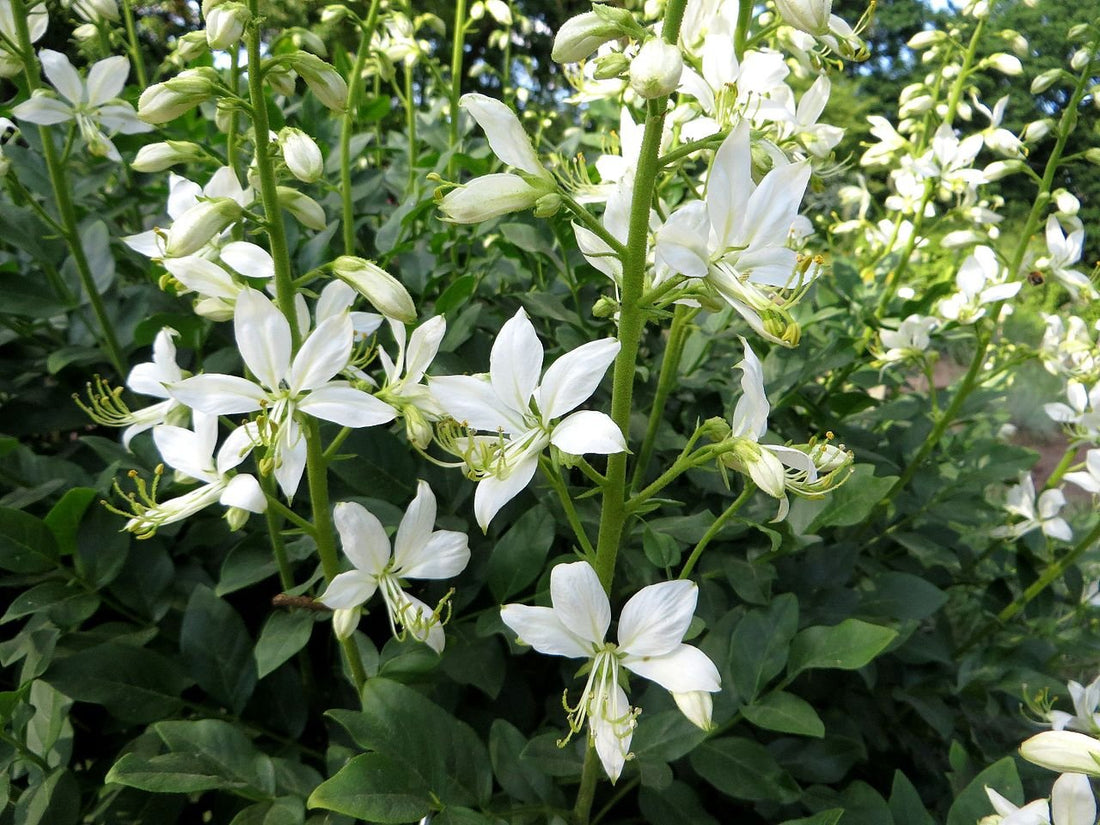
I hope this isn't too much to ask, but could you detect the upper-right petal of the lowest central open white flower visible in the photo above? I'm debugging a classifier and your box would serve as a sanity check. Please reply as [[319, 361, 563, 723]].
[[618, 580, 702, 660]]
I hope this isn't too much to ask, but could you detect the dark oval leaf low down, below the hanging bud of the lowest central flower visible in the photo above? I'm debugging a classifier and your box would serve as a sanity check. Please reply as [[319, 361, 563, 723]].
[[691, 738, 800, 804]]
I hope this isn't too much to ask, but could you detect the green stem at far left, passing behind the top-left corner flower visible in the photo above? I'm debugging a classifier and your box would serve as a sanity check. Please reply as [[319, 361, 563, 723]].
[[11, 0, 127, 376]]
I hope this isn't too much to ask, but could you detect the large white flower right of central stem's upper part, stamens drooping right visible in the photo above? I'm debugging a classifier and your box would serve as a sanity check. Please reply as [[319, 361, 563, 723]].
[[656, 121, 812, 347]]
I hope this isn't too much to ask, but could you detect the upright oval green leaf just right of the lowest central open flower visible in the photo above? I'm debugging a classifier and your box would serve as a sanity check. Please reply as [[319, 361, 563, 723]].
[[728, 593, 799, 703]]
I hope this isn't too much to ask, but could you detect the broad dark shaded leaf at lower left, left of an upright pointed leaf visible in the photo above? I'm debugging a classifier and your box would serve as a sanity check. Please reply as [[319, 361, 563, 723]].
[[43, 642, 188, 725]]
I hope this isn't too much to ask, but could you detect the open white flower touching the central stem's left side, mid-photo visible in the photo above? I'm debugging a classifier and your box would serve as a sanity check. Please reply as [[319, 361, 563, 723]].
[[430, 309, 626, 530]]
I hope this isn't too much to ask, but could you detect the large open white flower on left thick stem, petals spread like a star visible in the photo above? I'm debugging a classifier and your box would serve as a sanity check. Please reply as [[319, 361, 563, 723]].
[[168, 288, 396, 498]]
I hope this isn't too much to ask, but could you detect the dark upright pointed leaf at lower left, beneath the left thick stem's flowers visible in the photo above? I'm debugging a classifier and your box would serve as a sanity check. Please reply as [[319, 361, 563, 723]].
[[179, 584, 256, 714]]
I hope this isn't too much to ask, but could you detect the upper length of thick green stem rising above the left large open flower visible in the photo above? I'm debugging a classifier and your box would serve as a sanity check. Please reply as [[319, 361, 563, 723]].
[[246, 0, 301, 352]]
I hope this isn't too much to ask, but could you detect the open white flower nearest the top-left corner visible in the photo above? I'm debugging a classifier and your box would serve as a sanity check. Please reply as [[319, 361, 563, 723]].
[[12, 48, 153, 161]]
